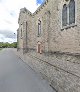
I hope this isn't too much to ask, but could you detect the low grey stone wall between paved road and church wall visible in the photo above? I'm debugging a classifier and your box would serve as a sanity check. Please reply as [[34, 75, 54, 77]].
[[17, 51, 80, 92]]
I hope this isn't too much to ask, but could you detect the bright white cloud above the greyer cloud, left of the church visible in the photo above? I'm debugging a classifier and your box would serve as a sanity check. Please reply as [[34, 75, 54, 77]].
[[0, 0, 38, 31]]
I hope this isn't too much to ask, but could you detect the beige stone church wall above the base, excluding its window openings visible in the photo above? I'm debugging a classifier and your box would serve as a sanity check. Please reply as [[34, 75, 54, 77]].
[[19, 0, 80, 53]]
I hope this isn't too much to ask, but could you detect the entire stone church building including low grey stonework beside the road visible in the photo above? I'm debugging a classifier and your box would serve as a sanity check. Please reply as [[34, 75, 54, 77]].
[[17, 0, 80, 92]]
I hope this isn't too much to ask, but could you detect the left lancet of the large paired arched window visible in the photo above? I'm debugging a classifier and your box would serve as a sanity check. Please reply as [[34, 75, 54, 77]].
[[62, 4, 67, 26]]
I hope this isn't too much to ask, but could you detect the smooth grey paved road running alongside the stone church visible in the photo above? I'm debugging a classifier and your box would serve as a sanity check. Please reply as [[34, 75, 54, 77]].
[[0, 49, 55, 92]]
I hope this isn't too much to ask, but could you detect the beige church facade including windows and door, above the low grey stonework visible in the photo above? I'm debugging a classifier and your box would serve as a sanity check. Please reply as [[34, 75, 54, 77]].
[[18, 0, 80, 53]]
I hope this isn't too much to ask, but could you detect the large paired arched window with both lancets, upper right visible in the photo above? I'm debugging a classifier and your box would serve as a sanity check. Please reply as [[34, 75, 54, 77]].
[[62, 0, 75, 27]]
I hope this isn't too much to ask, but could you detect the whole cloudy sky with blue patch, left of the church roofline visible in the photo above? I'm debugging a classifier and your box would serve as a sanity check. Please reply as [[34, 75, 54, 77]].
[[0, 0, 44, 43]]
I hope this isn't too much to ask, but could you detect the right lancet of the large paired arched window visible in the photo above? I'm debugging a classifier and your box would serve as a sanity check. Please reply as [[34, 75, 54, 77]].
[[69, 0, 75, 24]]
